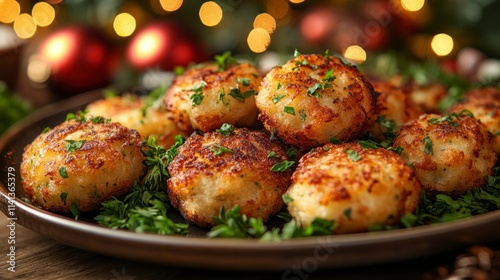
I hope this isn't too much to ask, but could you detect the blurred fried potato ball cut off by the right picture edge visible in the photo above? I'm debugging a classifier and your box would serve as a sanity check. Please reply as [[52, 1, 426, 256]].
[[449, 87, 500, 155]]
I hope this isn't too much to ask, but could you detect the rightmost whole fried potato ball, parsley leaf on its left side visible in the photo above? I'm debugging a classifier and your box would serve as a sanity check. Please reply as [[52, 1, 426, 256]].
[[393, 113, 497, 194]]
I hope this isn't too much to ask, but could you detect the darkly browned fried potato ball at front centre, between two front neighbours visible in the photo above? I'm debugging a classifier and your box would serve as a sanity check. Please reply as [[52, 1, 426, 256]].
[[167, 128, 292, 227]]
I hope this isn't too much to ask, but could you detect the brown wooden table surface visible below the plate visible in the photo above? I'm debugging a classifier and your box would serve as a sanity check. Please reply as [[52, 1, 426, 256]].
[[0, 212, 500, 280]]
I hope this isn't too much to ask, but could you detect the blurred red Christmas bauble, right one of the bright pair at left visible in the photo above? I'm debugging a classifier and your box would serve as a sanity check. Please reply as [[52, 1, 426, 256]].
[[125, 21, 208, 70]]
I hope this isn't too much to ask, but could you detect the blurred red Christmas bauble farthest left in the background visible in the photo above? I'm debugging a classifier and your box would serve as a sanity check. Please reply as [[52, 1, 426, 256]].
[[39, 26, 118, 96]]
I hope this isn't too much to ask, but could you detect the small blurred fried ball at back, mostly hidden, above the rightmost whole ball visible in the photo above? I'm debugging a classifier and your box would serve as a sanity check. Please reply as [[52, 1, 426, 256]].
[[403, 82, 448, 114]]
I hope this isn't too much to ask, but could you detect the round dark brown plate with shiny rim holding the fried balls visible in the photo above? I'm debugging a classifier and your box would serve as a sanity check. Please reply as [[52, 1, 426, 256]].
[[0, 91, 500, 271]]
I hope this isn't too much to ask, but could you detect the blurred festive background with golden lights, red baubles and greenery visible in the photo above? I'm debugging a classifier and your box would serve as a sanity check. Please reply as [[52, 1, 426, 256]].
[[0, 0, 500, 133]]
